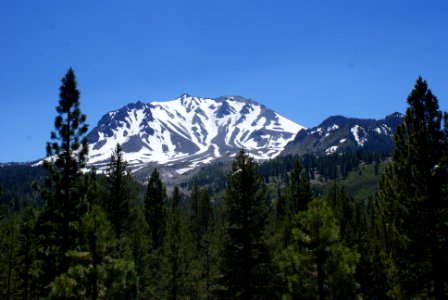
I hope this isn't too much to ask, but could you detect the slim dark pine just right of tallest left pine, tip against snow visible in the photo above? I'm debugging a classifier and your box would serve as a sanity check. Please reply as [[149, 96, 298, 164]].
[[104, 144, 135, 238]]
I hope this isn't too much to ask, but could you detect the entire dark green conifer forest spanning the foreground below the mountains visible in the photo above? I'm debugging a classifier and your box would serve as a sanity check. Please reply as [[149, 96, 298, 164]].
[[0, 69, 448, 300]]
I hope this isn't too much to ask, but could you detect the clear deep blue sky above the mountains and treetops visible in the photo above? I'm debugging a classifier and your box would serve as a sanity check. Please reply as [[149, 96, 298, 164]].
[[0, 0, 448, 162]]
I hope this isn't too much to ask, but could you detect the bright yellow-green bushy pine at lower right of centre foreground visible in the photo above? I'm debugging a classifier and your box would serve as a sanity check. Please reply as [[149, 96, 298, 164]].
[[280, 199, 359, 299]]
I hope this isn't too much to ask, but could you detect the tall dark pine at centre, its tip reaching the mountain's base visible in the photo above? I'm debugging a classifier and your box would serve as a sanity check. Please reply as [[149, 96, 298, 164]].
[[221, 150, 271, 299]]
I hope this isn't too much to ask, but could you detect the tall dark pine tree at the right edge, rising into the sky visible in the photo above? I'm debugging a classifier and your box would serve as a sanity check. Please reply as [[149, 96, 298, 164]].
[[380, 77, 448, 299]]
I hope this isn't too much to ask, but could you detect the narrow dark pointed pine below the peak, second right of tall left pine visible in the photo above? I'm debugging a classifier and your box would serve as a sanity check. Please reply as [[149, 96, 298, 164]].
[[144, 169, 166, 250]]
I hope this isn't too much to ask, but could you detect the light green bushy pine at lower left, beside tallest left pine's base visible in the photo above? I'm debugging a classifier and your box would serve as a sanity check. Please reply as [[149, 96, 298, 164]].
[[50, 206, 135, 299]]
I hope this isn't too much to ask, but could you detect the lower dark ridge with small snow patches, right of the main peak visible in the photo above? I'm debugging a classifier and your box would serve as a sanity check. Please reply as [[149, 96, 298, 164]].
[[282, 113, 403, 155]]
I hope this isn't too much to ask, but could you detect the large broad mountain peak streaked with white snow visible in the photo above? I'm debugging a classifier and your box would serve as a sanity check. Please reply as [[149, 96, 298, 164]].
[[88, 94, 304, 174]]
